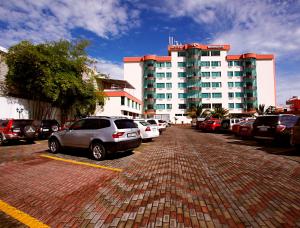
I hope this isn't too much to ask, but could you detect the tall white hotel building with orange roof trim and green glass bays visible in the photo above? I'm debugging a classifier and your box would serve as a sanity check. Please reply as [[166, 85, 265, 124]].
[[123, 43, 276, 122]]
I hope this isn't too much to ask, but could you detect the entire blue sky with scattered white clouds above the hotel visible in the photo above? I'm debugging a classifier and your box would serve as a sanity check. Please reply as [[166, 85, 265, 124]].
[[0, 0, 300, 104]]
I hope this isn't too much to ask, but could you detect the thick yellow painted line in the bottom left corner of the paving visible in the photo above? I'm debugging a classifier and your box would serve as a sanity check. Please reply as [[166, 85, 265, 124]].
[[0, 200, 49, 227]]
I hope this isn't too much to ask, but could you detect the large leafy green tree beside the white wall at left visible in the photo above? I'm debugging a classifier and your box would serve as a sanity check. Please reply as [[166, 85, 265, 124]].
[[6, 40, 103, 119]]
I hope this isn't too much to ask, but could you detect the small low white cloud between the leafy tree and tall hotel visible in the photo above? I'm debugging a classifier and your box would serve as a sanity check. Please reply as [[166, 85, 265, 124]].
[[93, 58, 123, 80]]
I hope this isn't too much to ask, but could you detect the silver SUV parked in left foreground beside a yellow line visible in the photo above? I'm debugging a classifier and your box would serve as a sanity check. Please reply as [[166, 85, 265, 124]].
[[48, 117, 141, 160]]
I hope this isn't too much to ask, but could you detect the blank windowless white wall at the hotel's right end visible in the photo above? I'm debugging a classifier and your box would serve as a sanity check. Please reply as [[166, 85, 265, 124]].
[[256, 60, 276, 107]]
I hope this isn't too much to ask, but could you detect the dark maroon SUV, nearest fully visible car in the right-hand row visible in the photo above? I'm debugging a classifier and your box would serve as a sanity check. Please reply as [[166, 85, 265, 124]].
[[253, 114, 298, 143]]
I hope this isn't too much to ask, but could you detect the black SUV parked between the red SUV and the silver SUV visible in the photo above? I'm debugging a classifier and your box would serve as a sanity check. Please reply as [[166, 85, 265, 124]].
[[34, 119, 60, 139]]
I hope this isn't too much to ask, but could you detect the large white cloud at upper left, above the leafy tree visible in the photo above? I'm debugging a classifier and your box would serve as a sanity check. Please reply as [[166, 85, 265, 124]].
[[0, 0, 139, 47]]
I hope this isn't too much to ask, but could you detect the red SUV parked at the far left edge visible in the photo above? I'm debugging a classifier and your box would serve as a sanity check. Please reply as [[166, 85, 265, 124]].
[[0, 119, 38, 145]]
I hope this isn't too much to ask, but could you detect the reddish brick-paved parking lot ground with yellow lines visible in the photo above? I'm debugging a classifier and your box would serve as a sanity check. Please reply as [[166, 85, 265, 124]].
[[0, 126, 300, 227]]
